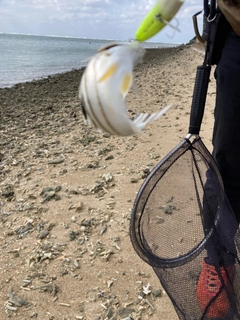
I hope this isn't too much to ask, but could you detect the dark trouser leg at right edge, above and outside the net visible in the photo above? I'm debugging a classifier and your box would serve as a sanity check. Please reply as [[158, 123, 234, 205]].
[[213, 32, 240, 222]]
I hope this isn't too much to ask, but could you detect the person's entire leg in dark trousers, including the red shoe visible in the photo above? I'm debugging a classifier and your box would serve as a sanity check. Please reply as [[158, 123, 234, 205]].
[[197, 32, 240, 319]]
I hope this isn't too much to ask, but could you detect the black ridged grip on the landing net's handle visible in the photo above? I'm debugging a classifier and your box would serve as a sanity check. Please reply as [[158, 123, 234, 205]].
[[188, 65, 211, 135]]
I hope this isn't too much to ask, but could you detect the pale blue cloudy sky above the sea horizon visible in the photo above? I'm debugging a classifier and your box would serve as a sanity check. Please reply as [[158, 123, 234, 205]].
[[0, 0, 202, 43]]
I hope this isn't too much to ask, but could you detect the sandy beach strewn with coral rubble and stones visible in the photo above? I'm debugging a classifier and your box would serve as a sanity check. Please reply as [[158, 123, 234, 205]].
[[0, 44, 216, 320]]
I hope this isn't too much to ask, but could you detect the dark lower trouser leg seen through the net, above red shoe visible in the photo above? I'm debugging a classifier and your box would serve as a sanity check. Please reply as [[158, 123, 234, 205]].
[[202, 169, 238, 267]]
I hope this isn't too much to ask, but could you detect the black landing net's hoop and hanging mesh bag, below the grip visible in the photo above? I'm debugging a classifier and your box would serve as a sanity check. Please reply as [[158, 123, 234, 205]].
[[130, 137, 240, 320]]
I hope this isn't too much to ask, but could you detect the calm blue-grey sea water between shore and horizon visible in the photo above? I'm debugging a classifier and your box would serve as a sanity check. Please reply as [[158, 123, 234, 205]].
[[0, 33, 176, 88]]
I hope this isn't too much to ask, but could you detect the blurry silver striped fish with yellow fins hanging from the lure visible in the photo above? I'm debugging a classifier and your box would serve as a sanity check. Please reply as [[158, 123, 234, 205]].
[[79, 41, 170, 136]]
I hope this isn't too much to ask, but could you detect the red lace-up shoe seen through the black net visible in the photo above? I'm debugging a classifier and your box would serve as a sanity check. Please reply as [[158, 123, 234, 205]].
[[197, 260, 235, 319]]
